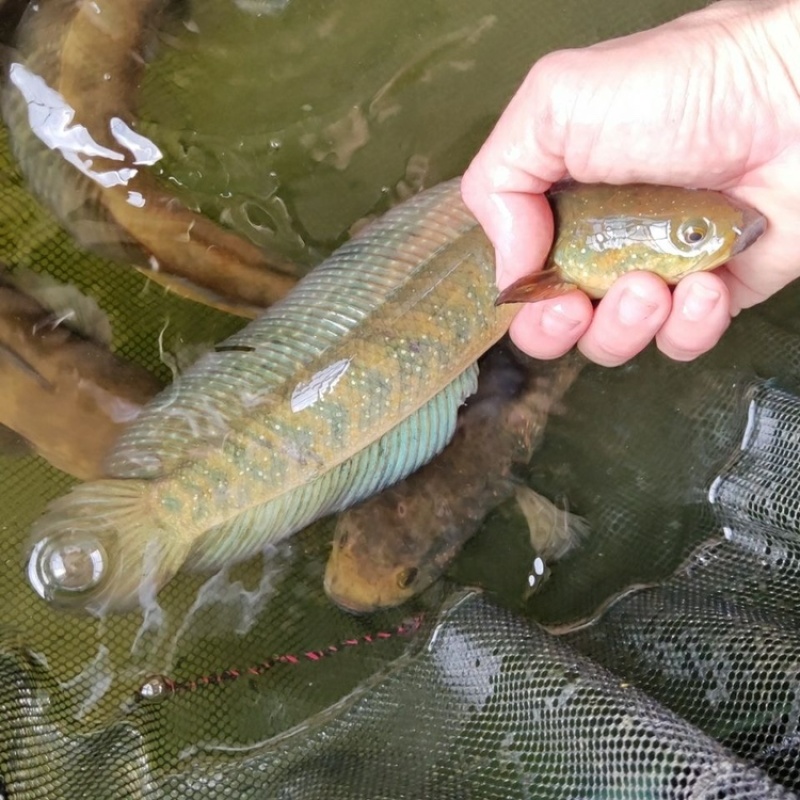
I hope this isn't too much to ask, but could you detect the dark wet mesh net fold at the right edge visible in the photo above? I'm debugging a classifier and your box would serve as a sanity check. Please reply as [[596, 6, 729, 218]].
[[567, 384, 800, 789]]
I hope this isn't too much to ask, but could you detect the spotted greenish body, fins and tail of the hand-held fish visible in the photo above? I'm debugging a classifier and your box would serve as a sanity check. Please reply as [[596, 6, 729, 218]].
[[23, 180, 764, 612]]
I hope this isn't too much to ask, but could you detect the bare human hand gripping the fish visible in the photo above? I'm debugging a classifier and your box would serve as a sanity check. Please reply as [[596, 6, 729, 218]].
[[462, 0, 800, 366]]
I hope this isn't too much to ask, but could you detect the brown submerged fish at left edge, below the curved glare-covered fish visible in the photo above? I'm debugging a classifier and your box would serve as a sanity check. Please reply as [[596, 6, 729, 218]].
[[0, 273, 161, 480]]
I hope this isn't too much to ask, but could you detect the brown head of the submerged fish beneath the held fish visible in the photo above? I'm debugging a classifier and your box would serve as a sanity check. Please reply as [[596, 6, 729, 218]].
[[324, 500, 449, 614]]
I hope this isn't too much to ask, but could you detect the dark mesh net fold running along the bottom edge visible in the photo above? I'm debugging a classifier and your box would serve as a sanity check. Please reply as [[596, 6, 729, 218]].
[[2, 592, 788, 798]]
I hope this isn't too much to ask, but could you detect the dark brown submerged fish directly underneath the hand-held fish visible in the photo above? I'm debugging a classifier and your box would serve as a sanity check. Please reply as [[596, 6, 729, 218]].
[[325, 348, 585, 613]]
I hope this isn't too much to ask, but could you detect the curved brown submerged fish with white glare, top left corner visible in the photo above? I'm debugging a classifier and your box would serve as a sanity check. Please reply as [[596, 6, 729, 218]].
[[3, 0, 296, 316]]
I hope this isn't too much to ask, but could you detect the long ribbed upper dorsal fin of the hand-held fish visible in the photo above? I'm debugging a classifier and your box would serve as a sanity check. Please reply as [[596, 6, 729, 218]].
[[109, 179, 477, 478]]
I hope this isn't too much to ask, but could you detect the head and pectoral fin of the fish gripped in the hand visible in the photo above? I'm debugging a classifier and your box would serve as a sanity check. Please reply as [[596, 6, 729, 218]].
[[497, 183, 766, 304]]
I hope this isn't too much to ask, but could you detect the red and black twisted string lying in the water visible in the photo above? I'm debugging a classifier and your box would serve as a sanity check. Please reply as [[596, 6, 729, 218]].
[[136, 615, 422, 702]]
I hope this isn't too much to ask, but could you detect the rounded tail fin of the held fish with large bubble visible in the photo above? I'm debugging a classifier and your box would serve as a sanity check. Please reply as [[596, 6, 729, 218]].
[[28, 479, 190, 616]]
